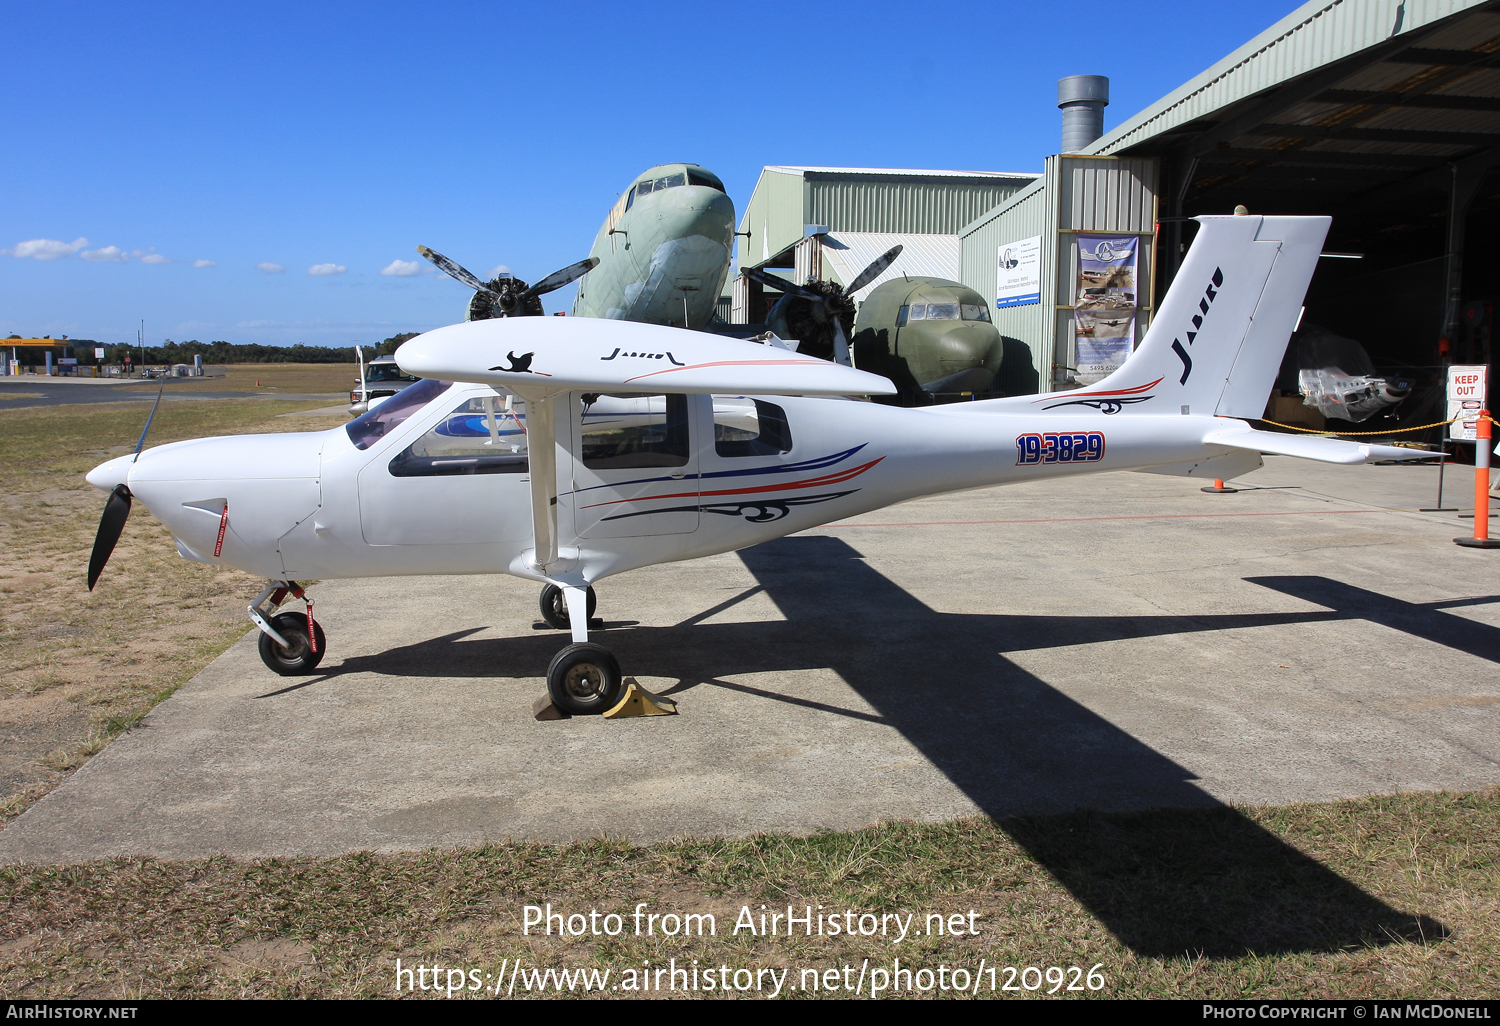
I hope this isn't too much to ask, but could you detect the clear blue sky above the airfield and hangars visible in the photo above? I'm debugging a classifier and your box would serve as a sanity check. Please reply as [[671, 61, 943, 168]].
[[0, 0, 1296, 345]]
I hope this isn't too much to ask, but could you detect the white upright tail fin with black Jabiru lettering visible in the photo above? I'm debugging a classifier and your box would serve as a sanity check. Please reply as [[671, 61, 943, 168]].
[[1068, 216, 1331, 417]]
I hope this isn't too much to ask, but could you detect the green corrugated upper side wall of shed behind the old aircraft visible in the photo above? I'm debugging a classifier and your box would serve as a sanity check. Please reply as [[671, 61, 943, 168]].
[[807, 174, 1026, 236]]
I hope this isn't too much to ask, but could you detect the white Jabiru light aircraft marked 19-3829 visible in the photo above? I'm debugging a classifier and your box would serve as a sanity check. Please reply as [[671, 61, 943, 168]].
[[89, 216, 1421, 713]]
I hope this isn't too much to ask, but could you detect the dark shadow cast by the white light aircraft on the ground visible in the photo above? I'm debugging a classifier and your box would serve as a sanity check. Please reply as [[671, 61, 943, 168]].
[[276, 536, 1482, 957]]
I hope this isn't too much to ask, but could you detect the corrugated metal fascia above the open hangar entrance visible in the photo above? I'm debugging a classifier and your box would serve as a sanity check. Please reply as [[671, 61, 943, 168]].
[[1088, 0, 1487, 153]]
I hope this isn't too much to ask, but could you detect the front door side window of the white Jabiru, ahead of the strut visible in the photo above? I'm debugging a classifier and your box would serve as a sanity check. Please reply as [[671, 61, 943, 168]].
[[390, 396, 527, 477]]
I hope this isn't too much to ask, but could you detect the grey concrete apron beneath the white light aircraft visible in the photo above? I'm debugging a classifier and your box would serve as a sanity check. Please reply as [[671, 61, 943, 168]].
[[0, 458, 1500, 863]]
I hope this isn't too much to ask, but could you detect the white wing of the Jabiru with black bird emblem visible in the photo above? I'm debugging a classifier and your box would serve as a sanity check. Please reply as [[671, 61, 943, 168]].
[[396, 317, 896, 396]]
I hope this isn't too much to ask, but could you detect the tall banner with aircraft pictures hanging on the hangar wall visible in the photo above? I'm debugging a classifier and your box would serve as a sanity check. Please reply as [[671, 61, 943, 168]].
[[1073, 236, 1140, 384]]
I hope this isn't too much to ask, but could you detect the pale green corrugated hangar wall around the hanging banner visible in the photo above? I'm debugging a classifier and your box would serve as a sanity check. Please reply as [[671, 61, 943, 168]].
[[960, 155, 1157, 392]]
